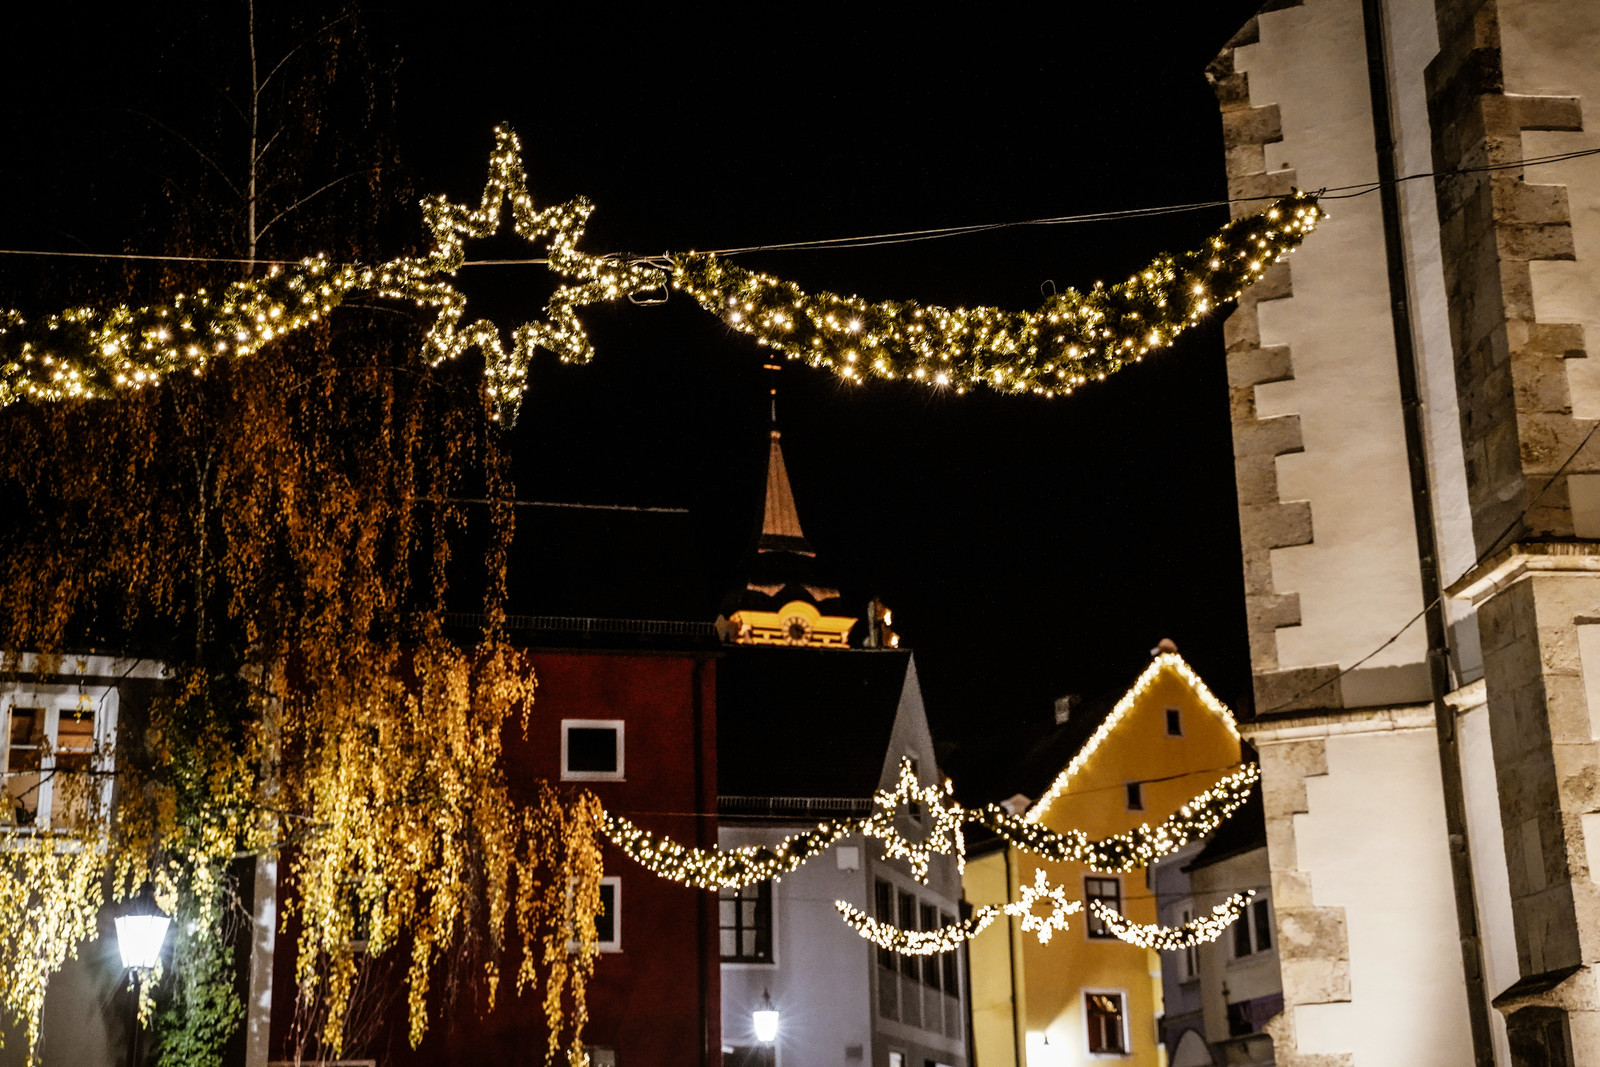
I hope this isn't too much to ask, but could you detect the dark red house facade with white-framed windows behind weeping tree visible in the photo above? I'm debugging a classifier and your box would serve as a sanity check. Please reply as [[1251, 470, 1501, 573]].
[[272, 648, 722, 1067]]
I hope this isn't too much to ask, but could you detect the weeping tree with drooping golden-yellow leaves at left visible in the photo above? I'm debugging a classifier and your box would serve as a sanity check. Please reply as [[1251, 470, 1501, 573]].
[[0, 10, 600, 1067]]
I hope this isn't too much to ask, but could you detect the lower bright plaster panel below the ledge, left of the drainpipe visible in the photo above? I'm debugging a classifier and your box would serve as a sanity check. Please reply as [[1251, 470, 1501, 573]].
[[1294, 728, 1472, 1067]]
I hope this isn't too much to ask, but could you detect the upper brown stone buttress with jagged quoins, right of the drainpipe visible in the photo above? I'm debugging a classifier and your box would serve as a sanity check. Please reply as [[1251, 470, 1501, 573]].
[[1427, 0, 1597, 553]]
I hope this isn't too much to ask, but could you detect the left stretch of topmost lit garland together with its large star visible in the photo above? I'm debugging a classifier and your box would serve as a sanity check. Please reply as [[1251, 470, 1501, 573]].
[[0, 128, 666, 421]]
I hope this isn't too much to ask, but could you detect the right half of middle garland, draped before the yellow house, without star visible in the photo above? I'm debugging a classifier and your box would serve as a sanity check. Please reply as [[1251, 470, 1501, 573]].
[[966, 763, 1261, 873]]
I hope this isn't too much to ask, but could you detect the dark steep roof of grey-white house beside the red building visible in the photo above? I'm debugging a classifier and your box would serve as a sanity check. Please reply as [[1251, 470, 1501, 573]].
[[717, 646, 910, 798]]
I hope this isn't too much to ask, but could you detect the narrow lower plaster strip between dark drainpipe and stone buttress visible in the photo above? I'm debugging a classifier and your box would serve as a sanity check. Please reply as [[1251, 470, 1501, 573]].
[[1456, 704, 1522, 1064]]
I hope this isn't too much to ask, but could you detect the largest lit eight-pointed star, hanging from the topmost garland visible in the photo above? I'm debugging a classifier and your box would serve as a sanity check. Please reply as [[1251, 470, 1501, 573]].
[[378, 126, 667, 422]]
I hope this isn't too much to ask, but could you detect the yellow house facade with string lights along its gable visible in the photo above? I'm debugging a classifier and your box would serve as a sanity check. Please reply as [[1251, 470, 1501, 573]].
[[962, 651, 1240, 1067]]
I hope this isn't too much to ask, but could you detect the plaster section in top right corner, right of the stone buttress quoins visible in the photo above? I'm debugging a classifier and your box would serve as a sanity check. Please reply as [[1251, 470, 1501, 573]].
[[1498, 0, 1600, 422]]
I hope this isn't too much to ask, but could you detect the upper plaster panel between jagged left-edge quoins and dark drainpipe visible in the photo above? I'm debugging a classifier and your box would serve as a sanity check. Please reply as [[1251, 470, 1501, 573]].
[[1235, 0, 1424, 667]]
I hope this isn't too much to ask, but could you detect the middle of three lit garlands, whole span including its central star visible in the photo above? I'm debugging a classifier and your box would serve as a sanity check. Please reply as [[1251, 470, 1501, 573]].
[[600, 763, 1261, 889]]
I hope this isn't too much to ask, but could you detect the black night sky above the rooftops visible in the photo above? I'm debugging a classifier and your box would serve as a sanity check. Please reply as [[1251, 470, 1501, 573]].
[[0, 0, 1256, 793]]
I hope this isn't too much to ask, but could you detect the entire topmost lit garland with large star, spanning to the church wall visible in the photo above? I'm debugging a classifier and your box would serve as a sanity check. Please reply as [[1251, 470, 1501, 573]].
[[0, 128, 1323, 422]]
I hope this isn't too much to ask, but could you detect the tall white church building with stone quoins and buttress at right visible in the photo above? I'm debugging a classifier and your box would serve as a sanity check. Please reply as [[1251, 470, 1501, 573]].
[[1211, 0, 1600, 1067]]
